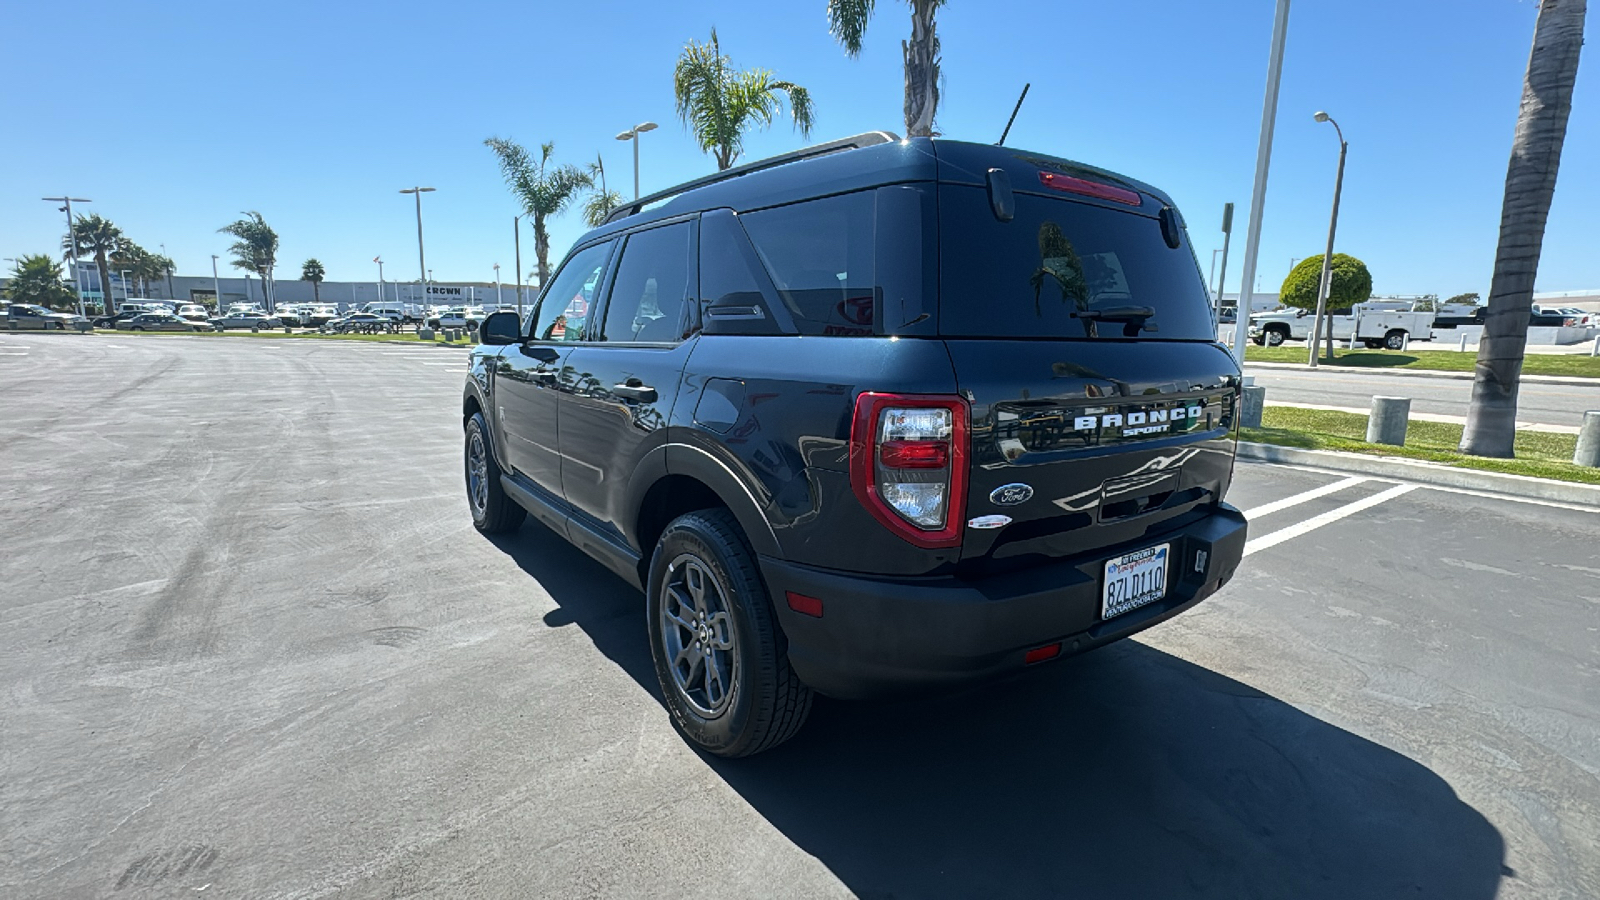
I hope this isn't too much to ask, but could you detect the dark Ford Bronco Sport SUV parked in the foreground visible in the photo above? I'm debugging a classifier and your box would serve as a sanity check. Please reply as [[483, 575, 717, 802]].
[[462, 133, 1245, 756]]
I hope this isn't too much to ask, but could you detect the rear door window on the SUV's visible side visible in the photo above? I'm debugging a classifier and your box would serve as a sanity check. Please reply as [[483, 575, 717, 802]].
[[600, 223, 691, 341]]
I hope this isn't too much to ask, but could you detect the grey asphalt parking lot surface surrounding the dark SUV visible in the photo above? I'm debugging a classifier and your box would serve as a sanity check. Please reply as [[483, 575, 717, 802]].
[[0, 335, 1600, 900]]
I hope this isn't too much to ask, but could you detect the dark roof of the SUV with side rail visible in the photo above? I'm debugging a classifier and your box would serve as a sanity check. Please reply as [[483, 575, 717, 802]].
[[579, 131, 1171, 243]]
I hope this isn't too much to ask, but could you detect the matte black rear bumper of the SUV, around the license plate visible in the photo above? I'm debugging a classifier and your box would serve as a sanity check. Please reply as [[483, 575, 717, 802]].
[[762, 504, 1246, 698]]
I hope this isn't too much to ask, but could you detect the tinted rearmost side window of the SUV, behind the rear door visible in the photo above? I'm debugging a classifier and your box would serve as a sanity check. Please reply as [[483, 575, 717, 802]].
[[739, 191, 878, 336]]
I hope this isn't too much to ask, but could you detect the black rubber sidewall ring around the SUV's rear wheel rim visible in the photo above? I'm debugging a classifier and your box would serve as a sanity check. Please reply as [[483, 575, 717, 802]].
[[645, 519, 766, 756]]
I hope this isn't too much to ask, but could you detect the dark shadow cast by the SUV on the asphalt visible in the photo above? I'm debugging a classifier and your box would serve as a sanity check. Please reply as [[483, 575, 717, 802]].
[[494, 524, 1510, 900]]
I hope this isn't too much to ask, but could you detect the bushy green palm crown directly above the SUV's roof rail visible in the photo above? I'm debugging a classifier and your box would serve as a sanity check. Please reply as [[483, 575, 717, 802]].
[[672, 29, 813, 171]]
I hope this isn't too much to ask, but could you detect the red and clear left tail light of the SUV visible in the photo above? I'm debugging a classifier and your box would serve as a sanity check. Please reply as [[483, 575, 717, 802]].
[[850, 392, 968, 548]]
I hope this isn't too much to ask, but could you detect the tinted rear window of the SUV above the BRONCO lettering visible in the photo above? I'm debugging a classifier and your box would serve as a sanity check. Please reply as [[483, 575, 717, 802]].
[[939, 184, 1216, 341]]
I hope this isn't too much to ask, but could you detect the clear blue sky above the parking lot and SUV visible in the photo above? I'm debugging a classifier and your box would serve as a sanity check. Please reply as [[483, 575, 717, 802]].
[[0, 0, 1600, 296]]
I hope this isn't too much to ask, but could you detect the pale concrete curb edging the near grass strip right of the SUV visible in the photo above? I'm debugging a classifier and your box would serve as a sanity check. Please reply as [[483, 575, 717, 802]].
[[1238, 440, 1600, 511]]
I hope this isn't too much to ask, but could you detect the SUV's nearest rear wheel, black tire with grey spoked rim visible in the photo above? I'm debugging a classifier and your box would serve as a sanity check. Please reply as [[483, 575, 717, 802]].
[[645, 509, 813, 757]]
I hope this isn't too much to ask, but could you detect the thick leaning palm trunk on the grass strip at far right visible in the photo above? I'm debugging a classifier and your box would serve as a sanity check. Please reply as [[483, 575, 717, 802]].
[[1461, 0, 1587, 460]]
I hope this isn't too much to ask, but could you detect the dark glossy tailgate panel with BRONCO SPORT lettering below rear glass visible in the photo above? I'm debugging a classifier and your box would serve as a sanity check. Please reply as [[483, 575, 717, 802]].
[[947, 340, 1238, 575]]
